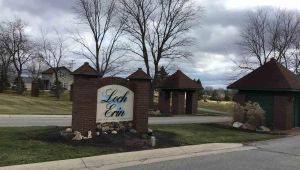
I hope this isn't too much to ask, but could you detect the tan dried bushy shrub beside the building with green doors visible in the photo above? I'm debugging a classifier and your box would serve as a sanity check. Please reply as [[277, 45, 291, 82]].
[[233, 101, 265, 128]]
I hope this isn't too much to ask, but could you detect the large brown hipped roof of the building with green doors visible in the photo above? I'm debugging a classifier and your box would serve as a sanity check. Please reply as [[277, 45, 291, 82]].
[[228, 59, 300, 91]]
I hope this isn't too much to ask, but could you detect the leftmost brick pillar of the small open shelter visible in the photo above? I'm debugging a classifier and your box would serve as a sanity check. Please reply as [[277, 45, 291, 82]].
[[158, 91, 171, 114]]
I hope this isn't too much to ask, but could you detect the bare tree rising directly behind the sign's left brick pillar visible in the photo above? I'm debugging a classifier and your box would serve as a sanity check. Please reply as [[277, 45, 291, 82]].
[[74, 0, 123, 76]]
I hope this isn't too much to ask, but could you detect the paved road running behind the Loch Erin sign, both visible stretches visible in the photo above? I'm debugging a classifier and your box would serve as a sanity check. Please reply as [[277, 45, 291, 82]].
[[0, 115, 231, 127]]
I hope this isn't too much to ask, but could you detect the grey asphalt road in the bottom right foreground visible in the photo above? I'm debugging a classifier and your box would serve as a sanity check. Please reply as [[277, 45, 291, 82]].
[[120, 136, 300, 170]]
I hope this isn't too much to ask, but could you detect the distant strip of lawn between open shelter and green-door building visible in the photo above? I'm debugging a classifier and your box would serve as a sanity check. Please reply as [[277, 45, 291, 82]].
[[198, 100, 234, 113]]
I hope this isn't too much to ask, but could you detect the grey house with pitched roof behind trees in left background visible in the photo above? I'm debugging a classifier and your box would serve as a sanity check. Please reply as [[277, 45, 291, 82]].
[[42, 67, 73, 90]]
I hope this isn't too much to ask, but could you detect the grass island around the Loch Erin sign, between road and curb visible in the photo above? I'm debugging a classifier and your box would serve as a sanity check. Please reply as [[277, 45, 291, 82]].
[[0, 124, 278, 166]]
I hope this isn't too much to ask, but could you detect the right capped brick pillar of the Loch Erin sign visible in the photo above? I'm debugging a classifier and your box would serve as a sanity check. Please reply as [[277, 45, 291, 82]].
[[128, 69, 151, 133]]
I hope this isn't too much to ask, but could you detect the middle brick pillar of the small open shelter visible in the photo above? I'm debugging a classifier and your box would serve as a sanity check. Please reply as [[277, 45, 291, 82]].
[[172, 91, 185, 115]]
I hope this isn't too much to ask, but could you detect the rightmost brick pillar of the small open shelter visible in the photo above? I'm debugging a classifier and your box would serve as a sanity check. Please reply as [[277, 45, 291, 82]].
[[186, 91, 198, 114]]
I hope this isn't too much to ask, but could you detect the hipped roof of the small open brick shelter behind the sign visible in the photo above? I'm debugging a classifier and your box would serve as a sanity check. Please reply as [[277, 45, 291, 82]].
[[158, 70, 203, 90]]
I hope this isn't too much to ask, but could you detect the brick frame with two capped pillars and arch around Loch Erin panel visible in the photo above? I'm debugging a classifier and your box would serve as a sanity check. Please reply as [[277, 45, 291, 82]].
[[72, 63, 151, 134]]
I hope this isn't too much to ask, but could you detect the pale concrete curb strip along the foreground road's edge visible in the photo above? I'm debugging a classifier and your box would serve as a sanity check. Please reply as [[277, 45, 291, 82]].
[[0, 143, 256, 170]]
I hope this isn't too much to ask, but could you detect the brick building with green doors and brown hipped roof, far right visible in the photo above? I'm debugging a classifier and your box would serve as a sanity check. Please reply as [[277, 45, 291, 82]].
[[228, 59, 300, 130]]
